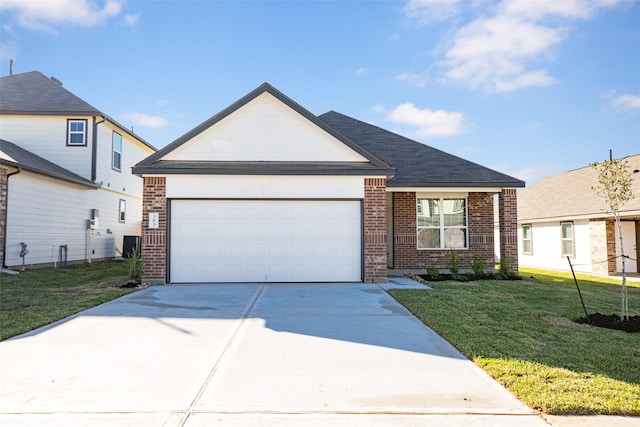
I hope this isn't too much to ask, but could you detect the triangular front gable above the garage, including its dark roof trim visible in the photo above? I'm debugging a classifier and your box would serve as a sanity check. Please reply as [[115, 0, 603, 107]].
[[134, 83, 393, 176]]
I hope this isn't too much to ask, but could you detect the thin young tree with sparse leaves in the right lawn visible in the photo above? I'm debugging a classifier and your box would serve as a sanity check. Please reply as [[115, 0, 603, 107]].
[[591, 159, 634, 320]]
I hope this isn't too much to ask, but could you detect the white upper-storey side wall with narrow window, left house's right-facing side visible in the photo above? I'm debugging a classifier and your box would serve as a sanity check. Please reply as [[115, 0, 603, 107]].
[[96, 122, 153, 198]]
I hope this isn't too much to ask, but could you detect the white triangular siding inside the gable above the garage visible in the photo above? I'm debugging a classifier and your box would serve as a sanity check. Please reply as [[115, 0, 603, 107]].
[[163, 93, 367, 162]]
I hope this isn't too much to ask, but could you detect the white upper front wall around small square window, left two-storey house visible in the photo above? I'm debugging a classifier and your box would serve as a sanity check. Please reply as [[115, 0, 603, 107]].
[[0, 115, 93, 179]]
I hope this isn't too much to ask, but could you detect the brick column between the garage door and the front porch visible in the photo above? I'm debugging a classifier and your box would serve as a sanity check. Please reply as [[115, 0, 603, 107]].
[[364, 178, 387, 283]]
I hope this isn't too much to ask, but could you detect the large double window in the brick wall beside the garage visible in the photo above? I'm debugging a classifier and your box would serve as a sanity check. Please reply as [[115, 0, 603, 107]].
[[416, 198, 468, 249]]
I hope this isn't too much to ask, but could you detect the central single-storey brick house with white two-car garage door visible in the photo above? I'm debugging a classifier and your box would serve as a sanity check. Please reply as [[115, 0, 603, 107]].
[[133, 83, 524, 283]]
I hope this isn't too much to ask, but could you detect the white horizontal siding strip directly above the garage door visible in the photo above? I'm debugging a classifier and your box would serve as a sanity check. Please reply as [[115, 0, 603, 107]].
[[167, 175, 364, 199]]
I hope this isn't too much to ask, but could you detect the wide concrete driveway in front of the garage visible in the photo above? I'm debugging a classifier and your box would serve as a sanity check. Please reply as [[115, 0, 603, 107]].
[[0, 284, 547, 427]]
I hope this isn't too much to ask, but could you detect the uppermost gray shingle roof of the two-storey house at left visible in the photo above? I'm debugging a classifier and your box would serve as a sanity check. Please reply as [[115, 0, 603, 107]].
[[0, 71, 102, 116]]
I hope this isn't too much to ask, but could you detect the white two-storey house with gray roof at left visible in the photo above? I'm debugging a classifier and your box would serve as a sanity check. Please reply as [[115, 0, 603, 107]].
[[0, 72, 155, 267]]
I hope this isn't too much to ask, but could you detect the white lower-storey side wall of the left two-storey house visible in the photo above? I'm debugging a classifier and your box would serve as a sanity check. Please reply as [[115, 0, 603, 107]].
[[6, 171, 142, 266]]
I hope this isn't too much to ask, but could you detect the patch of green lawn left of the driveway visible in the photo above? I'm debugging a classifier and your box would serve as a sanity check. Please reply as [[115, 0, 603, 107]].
[[0, 261, 132, 340]]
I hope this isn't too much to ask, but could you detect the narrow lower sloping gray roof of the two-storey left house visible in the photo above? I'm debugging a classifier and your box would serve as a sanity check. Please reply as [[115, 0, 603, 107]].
[[0, 139, 98, 188]]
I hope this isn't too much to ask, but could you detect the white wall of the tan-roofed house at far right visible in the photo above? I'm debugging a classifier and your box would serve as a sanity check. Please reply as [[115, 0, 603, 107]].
[[518, 220, 597, 273]]
